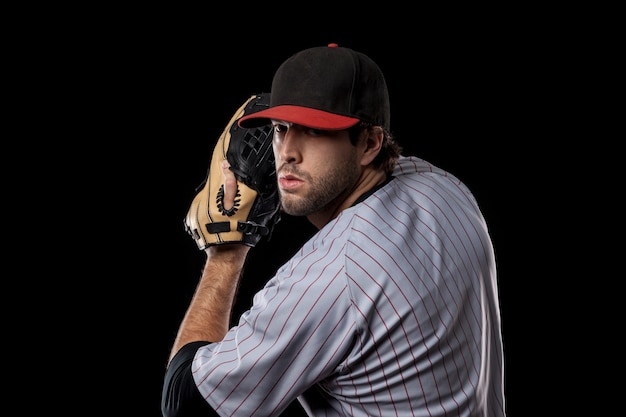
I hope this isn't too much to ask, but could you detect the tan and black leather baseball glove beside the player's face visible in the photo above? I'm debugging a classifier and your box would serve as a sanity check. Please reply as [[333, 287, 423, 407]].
[[184, 93, 280, 250]]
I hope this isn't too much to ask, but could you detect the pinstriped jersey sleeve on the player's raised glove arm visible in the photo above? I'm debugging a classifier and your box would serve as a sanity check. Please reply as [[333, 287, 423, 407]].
[[192, 224, 356, 417]]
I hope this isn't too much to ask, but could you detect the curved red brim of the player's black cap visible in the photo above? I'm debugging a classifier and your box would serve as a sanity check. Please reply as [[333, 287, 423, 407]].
[[238, 105, 359, 130]]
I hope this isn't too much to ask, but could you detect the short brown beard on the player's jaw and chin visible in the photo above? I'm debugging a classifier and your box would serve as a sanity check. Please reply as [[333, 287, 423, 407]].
[[280, 162, 361, 216]]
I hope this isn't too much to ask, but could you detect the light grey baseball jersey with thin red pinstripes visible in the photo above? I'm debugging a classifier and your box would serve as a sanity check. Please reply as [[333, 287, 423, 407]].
[[192, 157, 505, 417]]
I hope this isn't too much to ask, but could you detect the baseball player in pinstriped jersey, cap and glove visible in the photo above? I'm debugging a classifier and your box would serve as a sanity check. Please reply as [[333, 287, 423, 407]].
[[161, 44, 505, 417]]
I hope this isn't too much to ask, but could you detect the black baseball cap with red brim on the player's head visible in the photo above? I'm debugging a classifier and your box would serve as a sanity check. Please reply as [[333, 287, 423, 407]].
[[238, 43, 390, 130]]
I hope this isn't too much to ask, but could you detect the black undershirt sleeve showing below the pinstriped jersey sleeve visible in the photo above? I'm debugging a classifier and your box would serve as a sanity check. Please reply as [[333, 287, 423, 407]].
[[161, 342, 219, 417]]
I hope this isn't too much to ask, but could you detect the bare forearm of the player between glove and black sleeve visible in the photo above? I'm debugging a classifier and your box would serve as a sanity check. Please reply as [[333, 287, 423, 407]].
[[170, 244, 250, 360]]
